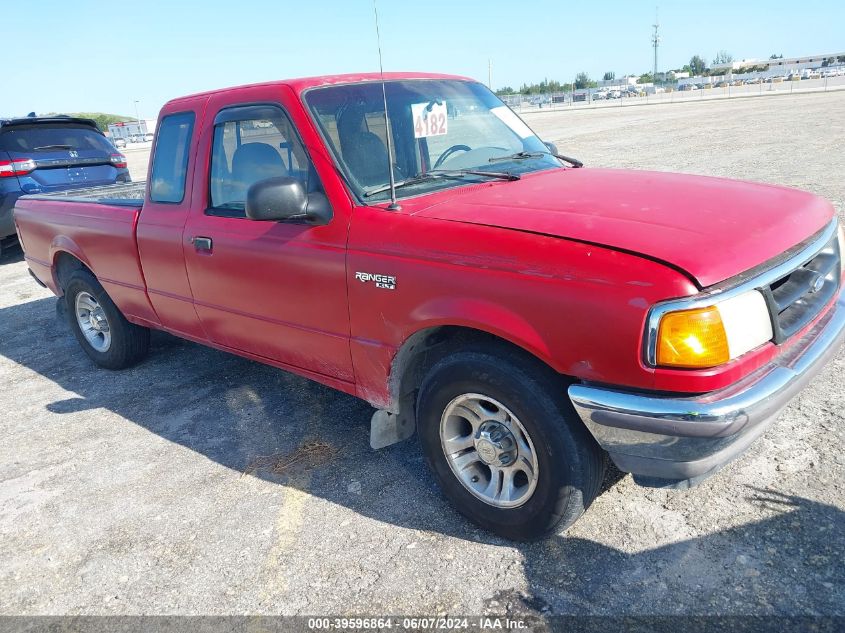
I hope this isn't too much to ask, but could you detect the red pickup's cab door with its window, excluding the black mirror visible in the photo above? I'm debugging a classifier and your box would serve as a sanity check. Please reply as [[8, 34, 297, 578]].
[[183, 94, 353, 382]]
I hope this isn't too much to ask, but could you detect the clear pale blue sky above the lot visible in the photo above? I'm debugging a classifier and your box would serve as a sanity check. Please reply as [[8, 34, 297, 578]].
[[0, 0, 845, 118]]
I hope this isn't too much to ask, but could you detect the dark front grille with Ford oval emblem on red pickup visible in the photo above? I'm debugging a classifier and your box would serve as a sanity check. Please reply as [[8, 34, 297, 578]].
[[762, 235, 842, 343]]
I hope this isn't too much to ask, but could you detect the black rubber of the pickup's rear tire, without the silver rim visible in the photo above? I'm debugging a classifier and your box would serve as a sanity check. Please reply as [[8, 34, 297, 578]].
[[64, 269, 150, 369]]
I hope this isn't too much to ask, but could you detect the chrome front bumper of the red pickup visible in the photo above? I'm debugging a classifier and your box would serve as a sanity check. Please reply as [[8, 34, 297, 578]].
[[569, 290, 845, 487]]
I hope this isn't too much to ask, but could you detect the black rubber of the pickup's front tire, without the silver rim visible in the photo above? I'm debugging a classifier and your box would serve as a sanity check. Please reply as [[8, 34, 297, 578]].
[[417, 345, 606, 541]]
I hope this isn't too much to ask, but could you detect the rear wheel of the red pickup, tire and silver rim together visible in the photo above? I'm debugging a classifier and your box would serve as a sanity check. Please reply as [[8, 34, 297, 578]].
[[64, 270, 150, 369]]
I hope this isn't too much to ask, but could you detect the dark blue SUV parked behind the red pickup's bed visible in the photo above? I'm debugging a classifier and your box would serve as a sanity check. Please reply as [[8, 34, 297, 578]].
[[0, 116, 131, 252]]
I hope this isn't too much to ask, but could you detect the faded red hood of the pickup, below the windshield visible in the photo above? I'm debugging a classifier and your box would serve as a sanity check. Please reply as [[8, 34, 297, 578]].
[[403, 168, 834, 286]]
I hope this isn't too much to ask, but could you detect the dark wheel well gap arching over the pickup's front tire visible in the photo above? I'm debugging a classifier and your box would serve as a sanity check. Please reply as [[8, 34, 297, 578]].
[[388, 326, 566, 421]]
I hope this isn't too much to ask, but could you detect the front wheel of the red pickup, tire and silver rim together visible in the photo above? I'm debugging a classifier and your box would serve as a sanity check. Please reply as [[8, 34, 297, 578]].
[[417, 348, 605, 540]]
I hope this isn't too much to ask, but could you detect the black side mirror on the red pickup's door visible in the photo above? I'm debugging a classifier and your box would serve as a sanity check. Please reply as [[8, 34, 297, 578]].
[[246, 176, 332, 224]]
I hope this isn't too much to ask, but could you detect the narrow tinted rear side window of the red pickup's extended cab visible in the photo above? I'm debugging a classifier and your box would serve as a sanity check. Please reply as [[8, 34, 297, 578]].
[[150, 112, 195, 204]]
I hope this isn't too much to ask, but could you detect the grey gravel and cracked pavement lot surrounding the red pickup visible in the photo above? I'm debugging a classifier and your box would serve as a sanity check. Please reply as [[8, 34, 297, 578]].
[[0, 92, 845, 615]]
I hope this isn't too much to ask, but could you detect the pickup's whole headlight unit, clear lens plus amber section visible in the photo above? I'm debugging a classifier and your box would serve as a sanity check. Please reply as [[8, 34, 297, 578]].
[[653, 290, 772, 369]]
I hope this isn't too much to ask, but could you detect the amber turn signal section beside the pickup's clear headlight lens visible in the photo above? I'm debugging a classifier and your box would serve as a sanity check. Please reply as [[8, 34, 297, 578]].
[[657, 306, 731, 369]]
